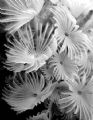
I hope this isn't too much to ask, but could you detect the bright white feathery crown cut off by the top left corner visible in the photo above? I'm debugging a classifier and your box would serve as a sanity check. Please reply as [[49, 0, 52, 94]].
[[0, 0, 44, 32]]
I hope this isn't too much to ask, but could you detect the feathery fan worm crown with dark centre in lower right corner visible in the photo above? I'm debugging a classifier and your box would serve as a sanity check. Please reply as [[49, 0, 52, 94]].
[[59, 74, 93, 120]]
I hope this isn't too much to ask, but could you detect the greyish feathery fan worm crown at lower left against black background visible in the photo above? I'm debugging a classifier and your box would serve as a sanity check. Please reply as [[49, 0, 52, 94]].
[[3, 72, 53, 113]]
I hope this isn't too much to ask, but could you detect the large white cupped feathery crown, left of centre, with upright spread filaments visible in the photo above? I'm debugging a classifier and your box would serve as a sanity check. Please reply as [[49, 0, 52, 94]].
[[6, 23, 57, 72]]
